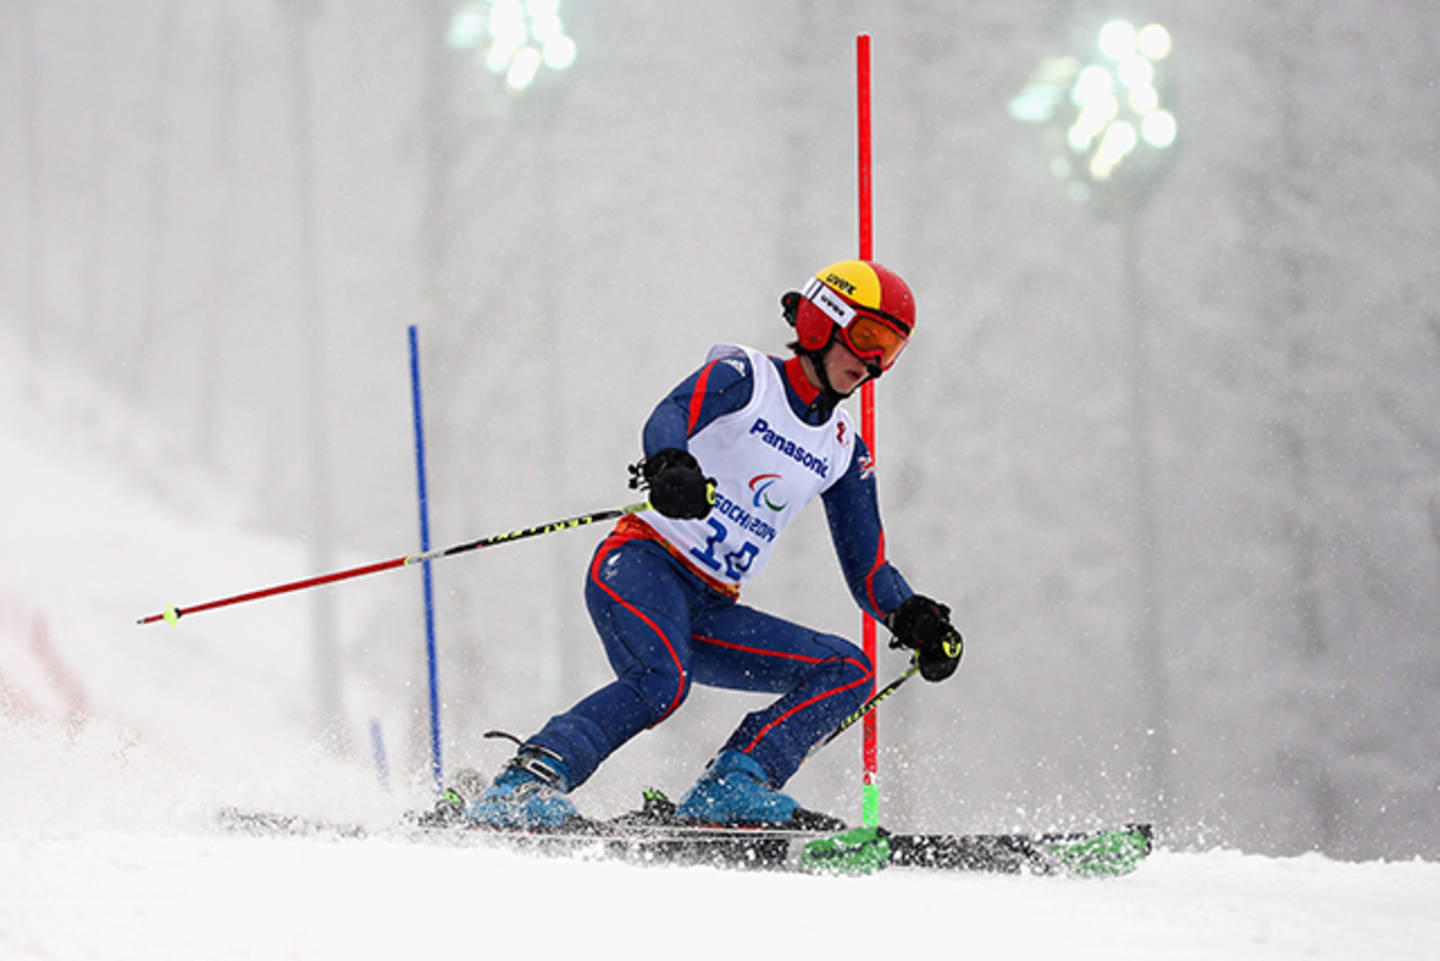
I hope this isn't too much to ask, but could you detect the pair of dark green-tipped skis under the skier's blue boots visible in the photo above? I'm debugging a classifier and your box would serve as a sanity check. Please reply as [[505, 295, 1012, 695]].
[[219, 808, 1153, 877]]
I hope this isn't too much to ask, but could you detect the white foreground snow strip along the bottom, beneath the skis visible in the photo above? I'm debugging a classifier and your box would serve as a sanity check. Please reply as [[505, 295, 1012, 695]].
[[0, 824, 1440, 961]]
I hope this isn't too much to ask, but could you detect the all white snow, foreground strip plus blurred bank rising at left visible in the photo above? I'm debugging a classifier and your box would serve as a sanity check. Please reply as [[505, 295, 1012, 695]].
[[0, 341, 1440, 961]]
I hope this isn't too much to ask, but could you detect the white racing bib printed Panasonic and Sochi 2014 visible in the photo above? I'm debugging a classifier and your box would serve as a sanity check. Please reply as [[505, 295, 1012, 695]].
[[641, 344, 855, 589]]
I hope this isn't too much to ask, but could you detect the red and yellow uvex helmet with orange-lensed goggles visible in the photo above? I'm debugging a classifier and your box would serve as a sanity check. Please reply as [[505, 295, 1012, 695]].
[[795, 261, 914, 370]]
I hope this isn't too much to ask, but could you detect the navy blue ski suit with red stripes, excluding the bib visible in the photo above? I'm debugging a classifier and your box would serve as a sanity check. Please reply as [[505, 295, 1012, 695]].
[[530, 350, 912, 790]]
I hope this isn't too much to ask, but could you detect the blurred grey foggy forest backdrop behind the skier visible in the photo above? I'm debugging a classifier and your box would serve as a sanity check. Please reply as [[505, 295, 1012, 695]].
[[0, 0, 1440, 857]]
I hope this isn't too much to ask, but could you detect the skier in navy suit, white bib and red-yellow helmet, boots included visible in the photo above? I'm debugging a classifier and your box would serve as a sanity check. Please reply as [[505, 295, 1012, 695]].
[[465, 261, 963, 828]]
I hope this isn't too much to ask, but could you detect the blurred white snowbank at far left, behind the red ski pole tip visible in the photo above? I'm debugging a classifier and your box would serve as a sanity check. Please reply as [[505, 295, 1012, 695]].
[[0, 332, 394, 824]]
